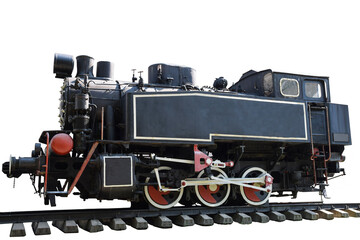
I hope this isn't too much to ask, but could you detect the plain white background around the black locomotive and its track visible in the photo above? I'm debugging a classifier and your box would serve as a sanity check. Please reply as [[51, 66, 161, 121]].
[[0, 0, 360, 240]]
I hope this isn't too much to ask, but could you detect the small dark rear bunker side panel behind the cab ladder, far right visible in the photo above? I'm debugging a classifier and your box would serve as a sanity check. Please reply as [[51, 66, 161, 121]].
[[329, 103, 351, 145]]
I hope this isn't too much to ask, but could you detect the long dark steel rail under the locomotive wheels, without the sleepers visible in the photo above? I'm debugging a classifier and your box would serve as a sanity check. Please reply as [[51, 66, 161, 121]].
[[0, 202, 360, 224]]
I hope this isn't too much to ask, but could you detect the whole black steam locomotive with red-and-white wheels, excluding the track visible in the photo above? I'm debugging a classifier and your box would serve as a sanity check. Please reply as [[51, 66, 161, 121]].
[[2, 54, 351, 209]]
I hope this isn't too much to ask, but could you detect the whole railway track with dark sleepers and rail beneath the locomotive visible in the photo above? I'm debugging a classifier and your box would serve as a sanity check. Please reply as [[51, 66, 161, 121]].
[[0, 202, 360, 237]]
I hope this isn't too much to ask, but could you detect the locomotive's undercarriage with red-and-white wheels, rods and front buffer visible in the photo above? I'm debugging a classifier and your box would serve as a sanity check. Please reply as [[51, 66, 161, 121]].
[[3, 142, 343, 209]]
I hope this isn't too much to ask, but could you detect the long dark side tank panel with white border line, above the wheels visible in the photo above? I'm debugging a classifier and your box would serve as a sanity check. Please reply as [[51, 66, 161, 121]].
[[128, 93, 308, 142]]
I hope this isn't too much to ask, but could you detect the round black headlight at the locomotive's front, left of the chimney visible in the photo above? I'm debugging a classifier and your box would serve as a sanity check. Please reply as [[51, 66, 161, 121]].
[[54, 53, 74, 78]]
